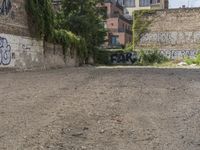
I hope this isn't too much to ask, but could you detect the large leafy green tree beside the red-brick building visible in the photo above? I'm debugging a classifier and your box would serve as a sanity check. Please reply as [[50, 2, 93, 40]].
[[57, 0, 106, 54]]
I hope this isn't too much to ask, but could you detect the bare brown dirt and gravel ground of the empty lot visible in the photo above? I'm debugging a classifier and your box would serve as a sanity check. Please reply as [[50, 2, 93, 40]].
[[0, 67, 200, 150]]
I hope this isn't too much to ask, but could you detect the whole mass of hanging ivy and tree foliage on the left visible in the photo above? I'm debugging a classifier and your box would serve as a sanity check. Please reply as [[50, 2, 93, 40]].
[[26, 0, 106, 59]]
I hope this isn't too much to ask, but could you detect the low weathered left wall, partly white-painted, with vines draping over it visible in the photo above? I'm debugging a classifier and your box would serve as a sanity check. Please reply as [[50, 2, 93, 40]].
[[0, 33, 78, 69]]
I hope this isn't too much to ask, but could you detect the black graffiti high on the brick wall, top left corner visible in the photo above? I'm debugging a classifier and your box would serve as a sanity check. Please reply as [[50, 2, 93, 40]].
[[0, 0, 12, 15]]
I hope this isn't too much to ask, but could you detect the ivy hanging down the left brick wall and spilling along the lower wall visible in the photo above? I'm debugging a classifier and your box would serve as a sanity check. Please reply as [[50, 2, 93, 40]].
[[25, 0, 87, 59]]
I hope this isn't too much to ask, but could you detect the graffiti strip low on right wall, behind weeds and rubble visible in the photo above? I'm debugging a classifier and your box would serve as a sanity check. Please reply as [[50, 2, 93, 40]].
[[160, 50, 200, 60]]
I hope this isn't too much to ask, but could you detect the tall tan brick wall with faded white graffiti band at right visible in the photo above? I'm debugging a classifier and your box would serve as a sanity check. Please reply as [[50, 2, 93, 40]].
[[138, 8, 200, 50]]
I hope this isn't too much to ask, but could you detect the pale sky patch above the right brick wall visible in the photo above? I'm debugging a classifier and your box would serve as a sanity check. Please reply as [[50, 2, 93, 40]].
[[169, 0, 200, 8]]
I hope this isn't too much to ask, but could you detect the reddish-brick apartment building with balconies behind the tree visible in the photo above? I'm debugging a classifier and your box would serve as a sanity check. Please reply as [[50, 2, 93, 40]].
[[101, 0, 132, 48]]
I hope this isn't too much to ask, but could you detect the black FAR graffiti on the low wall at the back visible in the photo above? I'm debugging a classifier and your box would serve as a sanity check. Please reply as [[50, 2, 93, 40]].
[[110, 52, 137, 64]]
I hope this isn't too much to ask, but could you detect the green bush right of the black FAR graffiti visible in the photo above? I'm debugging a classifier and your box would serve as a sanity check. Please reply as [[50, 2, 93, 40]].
[[139, 50, 168, 65]]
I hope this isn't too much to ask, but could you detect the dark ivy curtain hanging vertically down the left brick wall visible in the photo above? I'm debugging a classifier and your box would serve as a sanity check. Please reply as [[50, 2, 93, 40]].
[[25, 0, 54, 41]]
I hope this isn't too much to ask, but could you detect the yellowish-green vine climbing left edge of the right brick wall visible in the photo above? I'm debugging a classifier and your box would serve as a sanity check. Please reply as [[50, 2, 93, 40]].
[[133, 10, 155, 48]]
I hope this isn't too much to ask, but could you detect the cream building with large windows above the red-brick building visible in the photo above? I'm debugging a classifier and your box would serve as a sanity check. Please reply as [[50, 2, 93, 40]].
[[119, 0, 168, 19]]
